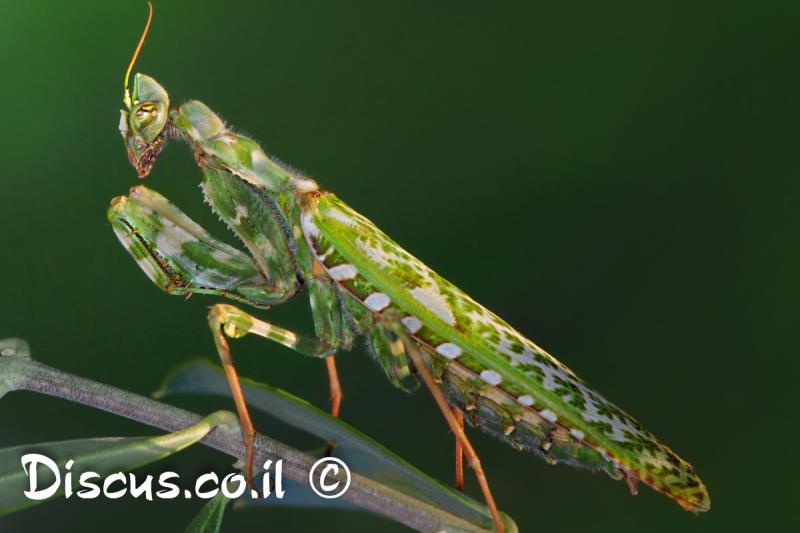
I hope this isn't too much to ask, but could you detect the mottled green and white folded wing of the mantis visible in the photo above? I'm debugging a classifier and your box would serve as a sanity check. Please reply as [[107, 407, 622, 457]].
[[303, 193, 710, 512]]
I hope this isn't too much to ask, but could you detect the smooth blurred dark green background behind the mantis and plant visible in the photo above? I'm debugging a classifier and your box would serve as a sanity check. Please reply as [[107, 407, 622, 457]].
[[0, 0, 800, 533]]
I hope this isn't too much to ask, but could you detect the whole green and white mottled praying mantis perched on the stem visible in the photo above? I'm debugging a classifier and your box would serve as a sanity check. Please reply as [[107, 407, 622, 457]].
[[108, 5, 710, 531]]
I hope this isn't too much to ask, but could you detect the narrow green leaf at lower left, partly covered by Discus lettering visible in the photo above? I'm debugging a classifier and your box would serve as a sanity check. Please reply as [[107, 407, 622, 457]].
[[0, 411, 238, 516]]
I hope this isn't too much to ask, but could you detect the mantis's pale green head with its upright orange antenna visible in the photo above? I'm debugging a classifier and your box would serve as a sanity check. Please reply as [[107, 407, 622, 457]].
[[119, 2, 169, 178]]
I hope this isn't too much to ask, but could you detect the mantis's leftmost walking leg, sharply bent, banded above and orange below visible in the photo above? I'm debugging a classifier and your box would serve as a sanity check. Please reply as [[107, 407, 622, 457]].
[[208, 304, 334, 486]]
